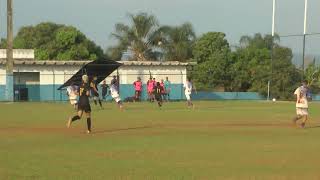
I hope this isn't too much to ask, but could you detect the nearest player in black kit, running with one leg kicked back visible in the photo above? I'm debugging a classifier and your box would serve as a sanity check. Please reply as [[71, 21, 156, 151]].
[[67, 75, 91, 134]]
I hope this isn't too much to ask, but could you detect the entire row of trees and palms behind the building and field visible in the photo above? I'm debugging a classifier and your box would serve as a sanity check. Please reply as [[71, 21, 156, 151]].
[[0, 13, 320, 99]]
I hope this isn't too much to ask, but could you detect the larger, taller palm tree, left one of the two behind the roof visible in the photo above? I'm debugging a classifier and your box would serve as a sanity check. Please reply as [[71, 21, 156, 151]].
[[109, 13, 158, 61]]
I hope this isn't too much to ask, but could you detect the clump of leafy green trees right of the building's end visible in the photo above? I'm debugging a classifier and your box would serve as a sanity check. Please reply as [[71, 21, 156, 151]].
[[193, 33, 301, 99]]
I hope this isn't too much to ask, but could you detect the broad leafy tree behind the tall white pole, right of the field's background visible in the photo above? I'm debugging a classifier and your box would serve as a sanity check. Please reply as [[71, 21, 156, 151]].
[[232, 34, 301, 99]]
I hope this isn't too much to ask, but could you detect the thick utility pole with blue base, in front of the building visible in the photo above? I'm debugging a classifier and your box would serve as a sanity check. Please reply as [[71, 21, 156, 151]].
[[6, 0, 14, 101]]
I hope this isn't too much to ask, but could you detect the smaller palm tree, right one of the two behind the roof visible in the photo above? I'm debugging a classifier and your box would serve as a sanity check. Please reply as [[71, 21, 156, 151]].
[[153, 23, 196, 61]]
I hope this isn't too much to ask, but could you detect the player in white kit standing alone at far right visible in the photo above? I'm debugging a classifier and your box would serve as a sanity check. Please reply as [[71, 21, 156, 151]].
[[293, 81, 309, 128]]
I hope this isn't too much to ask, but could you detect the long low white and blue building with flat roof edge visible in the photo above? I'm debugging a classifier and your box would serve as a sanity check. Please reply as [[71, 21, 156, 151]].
[[0, 59, 192, 101]]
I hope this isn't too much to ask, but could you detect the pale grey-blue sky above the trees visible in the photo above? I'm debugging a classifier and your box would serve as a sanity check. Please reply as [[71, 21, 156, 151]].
[[0, 0, 320, 57]]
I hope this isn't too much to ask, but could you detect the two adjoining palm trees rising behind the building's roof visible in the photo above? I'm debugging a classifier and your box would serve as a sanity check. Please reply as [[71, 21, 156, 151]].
[[107, 13, 196, 61]]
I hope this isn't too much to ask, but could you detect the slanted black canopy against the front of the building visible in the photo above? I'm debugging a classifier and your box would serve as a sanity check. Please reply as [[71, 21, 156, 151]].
[[58, 60, 122, 90]]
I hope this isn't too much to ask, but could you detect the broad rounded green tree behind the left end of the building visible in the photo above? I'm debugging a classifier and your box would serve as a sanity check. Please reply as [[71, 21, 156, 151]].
[[1, 22, 104, 60]]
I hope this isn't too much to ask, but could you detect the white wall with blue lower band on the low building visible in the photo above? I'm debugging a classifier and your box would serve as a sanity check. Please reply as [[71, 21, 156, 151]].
[[0, 65, 187, 101]]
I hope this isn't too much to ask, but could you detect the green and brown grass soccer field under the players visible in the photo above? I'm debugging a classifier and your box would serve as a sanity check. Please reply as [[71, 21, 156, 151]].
[[0, 101, 320, 180]]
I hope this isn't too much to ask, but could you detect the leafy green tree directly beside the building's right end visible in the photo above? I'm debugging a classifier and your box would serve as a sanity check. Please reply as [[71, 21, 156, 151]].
[[192, 32, 231, 91]]
